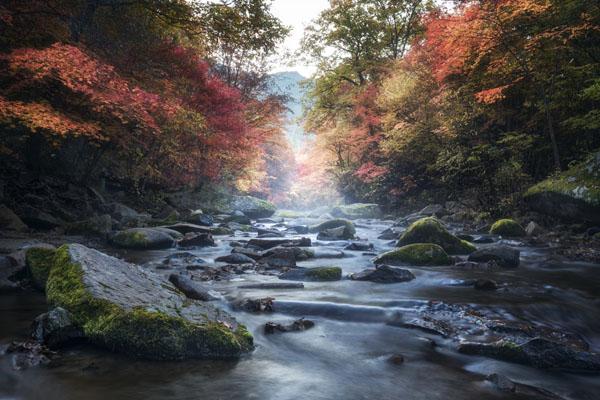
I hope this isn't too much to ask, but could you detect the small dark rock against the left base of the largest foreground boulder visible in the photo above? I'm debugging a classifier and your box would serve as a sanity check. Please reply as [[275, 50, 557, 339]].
[[31, 307, 83, 349]]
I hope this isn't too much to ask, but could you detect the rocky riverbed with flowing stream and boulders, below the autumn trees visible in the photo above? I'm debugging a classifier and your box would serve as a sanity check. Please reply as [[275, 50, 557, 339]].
[[0, 203, 600, 399]]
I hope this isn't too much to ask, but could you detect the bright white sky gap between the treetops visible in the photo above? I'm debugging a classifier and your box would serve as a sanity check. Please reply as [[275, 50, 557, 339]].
[[271, 0, 329, 77]]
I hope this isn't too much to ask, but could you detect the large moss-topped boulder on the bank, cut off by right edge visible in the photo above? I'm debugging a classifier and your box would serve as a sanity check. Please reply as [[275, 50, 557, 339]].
[[524, 152, 600, 224]]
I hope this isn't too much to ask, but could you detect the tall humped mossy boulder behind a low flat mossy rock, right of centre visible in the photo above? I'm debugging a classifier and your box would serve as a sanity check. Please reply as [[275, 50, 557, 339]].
[[397, 217, 476, 254]]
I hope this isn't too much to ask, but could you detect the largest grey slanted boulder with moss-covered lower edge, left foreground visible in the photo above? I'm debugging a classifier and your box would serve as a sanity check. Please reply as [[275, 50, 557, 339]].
[[46, 244, 253, 360]]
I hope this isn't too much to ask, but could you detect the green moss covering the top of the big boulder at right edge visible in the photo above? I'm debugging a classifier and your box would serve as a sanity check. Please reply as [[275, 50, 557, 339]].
[[524, 153, 600, 206]]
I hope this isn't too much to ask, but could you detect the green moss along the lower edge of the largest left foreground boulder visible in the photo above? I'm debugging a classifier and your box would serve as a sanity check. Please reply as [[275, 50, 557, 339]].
[[47, 245, 252, 360]]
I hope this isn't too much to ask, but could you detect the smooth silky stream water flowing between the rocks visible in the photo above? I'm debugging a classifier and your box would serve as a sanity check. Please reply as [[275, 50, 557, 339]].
[[0, 220, 600, 400]]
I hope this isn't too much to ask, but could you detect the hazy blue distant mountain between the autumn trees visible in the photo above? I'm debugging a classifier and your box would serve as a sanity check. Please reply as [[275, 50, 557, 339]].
[[268, 71, 313, 151]]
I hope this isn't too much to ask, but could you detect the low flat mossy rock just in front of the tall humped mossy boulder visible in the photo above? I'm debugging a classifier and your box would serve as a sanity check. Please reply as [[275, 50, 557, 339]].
[[373, 243, 452, 266]]
